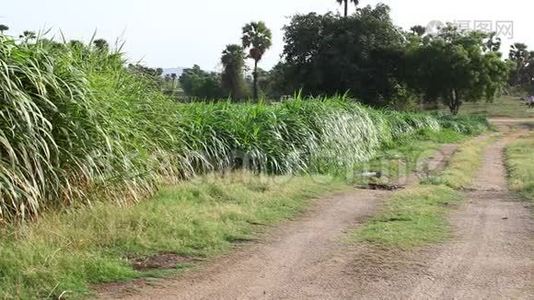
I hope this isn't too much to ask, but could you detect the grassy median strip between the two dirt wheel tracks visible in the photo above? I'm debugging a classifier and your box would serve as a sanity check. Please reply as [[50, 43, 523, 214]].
[[351, 134, 489, 249]]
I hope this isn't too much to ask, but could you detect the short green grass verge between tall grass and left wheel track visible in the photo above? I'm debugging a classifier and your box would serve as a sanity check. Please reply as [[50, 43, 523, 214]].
[[0, 129, 472, 299]]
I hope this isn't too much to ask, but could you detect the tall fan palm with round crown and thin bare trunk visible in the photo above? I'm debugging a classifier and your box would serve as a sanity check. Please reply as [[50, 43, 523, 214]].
[[242, 21, 272, 100]]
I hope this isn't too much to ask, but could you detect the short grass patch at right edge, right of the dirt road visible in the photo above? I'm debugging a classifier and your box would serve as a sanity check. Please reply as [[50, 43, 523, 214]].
[[506, 135, 534, 201]]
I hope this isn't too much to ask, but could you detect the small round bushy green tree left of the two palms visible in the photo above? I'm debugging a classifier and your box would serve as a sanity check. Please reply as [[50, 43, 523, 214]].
[[179, 65, 225, 100]]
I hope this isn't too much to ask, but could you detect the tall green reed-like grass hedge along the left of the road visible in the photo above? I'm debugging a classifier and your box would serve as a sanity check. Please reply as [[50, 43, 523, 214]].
[[0, 35, 490, 221]]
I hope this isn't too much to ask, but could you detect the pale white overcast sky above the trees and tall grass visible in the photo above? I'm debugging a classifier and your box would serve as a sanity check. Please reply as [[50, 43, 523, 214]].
[[0, 0, 534, 71]]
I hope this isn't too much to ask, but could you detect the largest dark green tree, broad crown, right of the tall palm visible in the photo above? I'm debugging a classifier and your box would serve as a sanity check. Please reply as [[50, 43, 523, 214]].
[[280, 4, 406, 106]]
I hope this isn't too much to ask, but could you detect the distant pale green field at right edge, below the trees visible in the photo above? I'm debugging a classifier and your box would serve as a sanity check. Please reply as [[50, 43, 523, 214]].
[[434, 96, 534, 118]]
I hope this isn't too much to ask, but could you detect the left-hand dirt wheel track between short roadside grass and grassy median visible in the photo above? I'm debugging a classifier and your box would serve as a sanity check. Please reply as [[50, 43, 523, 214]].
[[100, 145, 456, 299]]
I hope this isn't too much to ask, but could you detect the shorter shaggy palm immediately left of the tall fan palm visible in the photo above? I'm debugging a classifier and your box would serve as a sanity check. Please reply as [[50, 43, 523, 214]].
[[221, 44, 246, 99]]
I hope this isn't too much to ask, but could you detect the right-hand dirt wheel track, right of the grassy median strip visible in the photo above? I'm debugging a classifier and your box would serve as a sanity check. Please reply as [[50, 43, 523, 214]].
[[411, 139, 534, 299]]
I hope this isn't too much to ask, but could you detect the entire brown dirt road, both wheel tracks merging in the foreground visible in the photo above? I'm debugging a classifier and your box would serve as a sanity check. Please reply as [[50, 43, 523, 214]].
[[102, 130, 534, 299]]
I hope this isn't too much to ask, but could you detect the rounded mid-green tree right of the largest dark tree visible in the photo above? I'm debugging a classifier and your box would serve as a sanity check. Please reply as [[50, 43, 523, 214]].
[[406, 26, 508, 114]]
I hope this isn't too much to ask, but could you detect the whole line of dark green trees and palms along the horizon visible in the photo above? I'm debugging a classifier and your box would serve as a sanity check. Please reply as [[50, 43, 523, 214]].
[[0, 0, 534, 114]]
